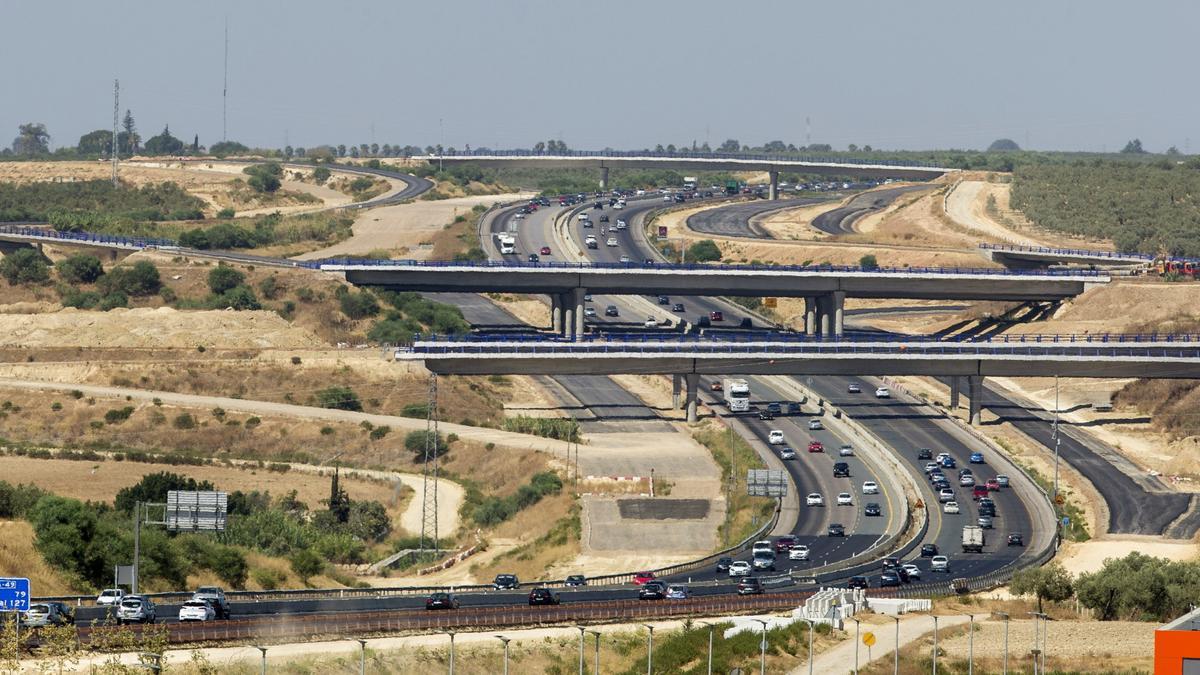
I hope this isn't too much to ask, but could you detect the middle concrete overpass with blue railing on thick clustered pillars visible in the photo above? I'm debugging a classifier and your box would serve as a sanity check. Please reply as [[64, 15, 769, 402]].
[[319, 259, 1109, 336]]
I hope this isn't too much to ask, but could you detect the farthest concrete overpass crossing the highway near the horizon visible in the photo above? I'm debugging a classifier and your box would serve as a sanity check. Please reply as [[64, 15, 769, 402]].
[[425, 150, 958, 199]]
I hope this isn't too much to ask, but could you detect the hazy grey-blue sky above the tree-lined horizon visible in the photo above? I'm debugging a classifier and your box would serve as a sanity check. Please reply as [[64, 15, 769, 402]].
[[0, 0, 1200, 151]]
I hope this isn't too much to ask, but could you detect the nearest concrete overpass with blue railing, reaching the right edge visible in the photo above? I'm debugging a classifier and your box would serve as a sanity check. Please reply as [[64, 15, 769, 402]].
[[395, 334, 1200, 423]]
